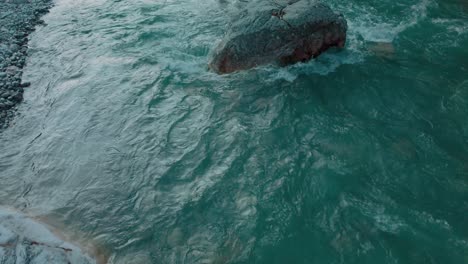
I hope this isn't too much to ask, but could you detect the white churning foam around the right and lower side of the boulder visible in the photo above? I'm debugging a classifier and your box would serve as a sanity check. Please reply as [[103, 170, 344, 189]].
[[254, 0, 433, 82]]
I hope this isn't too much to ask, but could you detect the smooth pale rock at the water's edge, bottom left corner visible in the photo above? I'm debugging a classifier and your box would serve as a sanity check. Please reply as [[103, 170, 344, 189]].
[[0, 208, 96, 264]]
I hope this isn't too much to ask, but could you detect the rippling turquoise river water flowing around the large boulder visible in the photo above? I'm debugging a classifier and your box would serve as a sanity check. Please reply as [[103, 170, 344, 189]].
[[0, 0, 468, 264]]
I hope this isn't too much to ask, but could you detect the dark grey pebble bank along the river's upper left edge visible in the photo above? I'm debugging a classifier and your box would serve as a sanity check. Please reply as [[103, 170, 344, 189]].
[[0, 0, 52, 130]]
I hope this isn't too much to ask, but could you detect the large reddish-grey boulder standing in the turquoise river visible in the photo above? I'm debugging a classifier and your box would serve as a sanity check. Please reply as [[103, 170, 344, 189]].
[[209, 0, 347, 74]]
